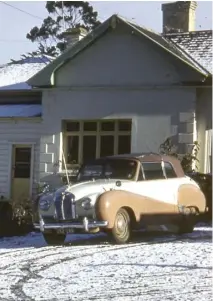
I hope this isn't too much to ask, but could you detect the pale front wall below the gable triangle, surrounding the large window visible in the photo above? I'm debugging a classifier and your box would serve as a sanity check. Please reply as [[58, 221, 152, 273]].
[[40, 88, 195, 178]]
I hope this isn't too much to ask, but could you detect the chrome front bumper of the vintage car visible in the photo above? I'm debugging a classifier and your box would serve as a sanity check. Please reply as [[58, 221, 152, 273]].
[[34, 216, 108, 232]]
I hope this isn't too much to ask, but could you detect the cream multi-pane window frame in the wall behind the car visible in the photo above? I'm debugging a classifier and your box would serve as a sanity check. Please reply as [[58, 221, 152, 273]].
[[62, 118, 132, 168]]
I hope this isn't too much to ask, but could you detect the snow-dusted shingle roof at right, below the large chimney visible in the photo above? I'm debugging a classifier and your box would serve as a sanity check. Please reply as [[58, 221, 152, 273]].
[[164, 30, 213, 74]]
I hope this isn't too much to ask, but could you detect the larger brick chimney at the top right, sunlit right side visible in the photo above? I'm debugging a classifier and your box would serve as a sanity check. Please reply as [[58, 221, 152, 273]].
[[161, 1, 197, 33]]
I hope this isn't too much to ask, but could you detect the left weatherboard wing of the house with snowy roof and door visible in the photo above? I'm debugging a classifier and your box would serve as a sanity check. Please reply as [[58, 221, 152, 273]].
[[0, 56, 51, 199]]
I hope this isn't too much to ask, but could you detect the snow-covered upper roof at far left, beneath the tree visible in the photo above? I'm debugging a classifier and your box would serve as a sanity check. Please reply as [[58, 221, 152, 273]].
[[0, 55, 52, 91]]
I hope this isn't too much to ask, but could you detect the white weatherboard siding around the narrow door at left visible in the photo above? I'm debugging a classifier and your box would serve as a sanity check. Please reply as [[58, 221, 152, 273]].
[[0, 118, 41, 198]]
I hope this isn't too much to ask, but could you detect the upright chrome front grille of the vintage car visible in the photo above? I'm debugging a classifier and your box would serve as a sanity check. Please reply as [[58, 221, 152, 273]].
[[55, 193, 75, 220]]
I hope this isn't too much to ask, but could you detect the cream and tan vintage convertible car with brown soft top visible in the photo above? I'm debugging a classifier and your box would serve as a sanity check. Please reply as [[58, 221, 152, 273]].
[[34, 154, 206, 244]]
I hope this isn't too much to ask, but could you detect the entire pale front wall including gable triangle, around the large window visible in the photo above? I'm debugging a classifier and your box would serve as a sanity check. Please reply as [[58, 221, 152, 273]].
[[40, 27, 198, 179]]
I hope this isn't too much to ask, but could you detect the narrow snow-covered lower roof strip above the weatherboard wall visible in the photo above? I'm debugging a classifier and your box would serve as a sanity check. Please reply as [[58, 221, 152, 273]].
[[0, 104, 42, 118]]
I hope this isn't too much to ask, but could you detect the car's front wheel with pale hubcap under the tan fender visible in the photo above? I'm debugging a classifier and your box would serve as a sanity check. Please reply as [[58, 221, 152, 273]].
[[111, 208, 131, 244]]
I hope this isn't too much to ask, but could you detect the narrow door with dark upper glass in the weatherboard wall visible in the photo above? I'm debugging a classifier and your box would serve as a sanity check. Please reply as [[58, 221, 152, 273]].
[[11, 144, 32, 201]]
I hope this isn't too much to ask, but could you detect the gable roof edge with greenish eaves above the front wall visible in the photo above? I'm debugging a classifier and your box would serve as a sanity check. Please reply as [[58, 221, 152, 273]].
[[28, 15, 207, 87]]
